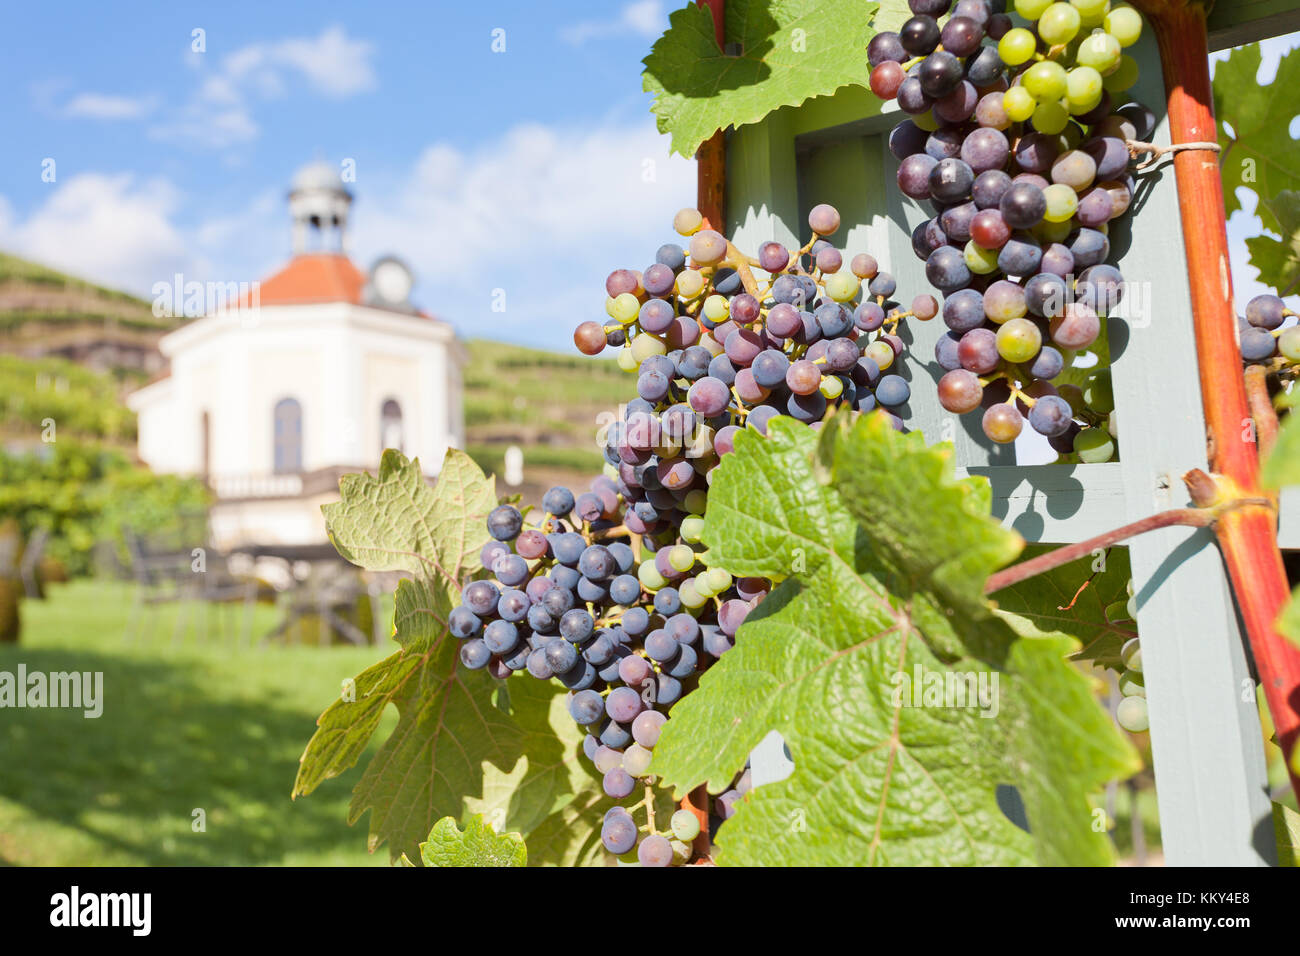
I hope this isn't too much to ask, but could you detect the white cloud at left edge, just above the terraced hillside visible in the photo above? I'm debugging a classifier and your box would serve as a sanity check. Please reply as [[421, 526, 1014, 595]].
[[0, 173, 187, 293]]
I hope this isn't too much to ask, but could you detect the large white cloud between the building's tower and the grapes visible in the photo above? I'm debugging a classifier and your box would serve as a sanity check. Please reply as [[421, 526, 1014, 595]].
[[354, 120, 696, 349]]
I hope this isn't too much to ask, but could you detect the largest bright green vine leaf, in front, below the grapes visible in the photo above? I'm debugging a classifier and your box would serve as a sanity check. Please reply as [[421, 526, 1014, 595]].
[[651, 415, 1140, 865]]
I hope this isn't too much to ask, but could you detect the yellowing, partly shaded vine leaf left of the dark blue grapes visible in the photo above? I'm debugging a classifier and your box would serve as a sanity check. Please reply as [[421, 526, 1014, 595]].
[[293, 450, 589, 858]]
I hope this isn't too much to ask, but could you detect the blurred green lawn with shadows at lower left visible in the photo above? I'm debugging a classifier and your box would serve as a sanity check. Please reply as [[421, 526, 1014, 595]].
[[0, 581, 397, 866]]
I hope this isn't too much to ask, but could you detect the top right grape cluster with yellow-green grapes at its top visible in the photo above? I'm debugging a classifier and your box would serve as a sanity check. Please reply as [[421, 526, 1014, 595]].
[[867, 0, 1154, 462]]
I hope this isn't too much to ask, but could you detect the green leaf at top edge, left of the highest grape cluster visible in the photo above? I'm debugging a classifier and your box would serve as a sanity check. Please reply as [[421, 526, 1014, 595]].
[[642, 0, 910, 159]]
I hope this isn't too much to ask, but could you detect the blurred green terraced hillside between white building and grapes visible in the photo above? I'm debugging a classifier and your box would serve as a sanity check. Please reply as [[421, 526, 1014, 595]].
[[464, 338, 633, 503]]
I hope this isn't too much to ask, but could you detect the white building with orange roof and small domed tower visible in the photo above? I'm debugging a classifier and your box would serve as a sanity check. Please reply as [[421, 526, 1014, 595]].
[[127, 163, 465, 548]]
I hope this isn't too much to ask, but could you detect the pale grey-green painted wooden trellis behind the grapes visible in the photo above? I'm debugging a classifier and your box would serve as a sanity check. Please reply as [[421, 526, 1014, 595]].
[[722, 0, 1300, 866]]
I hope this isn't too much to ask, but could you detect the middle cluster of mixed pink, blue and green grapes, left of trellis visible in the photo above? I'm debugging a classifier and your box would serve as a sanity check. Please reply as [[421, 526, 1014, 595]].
[[573, 204, 939, 434]]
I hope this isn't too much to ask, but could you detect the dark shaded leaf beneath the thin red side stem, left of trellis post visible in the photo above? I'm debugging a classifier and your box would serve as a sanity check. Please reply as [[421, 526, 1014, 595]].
[[993, 545, 1138, 671]]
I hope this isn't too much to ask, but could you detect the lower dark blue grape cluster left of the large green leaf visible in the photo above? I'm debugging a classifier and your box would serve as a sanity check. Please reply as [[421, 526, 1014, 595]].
[[447, 475, 770, 866]]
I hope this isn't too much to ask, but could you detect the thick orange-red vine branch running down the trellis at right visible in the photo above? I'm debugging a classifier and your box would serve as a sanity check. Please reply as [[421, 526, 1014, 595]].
[[1138, 0, 1300, 795]]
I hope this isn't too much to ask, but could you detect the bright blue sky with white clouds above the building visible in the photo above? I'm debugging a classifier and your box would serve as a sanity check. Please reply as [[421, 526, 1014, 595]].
[[0, 0, 1296, 349]]
